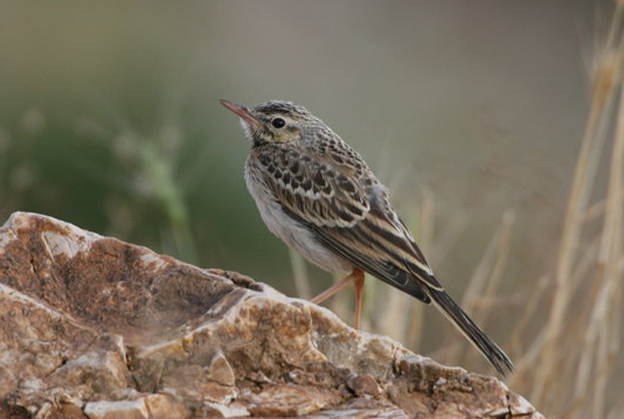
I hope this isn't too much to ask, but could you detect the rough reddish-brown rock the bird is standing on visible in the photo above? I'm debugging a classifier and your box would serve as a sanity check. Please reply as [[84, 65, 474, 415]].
[[0, 213, 542, 419]]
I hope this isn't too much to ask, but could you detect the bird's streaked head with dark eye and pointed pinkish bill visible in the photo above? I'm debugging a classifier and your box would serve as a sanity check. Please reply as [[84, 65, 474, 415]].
[[220, 99, 320, 146]]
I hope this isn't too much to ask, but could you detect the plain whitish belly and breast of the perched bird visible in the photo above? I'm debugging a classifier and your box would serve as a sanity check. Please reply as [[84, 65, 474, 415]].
[[245, 166, 354, 272]]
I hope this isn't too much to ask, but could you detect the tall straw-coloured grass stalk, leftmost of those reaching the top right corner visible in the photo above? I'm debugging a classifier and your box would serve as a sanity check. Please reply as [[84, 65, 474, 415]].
[[532, 5, 622, 406]]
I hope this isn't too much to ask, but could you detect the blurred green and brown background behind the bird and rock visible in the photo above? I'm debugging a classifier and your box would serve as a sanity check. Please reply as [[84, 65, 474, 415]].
[[0, 0, 624, 417]]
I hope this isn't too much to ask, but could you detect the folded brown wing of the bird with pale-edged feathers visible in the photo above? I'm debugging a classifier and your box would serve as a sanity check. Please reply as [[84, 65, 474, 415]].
[[255, 147, 443, 296]]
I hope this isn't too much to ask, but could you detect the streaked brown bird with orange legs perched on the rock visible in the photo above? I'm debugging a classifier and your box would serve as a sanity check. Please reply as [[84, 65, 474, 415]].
[[220, 99, 515, 376]]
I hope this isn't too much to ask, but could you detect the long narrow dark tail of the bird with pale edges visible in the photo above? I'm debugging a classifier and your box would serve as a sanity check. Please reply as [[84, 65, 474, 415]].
[[429, 288, 515, 376]]
